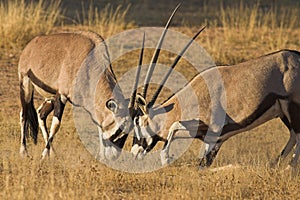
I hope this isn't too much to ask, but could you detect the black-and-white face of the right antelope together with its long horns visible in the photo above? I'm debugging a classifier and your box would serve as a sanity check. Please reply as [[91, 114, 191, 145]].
[[131, 26, 205, 158]]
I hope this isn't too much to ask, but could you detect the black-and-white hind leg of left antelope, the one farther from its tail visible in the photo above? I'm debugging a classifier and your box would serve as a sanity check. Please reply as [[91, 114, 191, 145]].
[[42, 94, 67, 159]]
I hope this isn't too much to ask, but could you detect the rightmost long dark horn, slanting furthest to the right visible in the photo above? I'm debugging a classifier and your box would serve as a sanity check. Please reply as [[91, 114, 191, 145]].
[[147, 26, 206, 108]]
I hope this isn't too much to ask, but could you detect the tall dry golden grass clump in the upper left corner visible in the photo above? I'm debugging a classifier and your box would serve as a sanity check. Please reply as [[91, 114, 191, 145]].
[[0, 0, 61, 56]]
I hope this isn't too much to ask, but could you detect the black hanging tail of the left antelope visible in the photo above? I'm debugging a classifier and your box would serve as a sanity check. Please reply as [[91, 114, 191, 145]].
[[20, 80, 39, 144]]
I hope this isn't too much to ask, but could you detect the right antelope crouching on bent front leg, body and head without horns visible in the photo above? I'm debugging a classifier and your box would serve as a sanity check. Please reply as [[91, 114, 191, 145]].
[[133, 50, 300, 173]]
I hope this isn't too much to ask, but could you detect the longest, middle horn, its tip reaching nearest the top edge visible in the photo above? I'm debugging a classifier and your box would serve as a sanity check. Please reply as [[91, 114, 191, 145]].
[[142, 4, 180, 98]]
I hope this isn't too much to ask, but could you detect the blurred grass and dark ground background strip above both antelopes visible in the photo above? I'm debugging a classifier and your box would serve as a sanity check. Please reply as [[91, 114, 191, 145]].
[[0, 0, 300, 64]]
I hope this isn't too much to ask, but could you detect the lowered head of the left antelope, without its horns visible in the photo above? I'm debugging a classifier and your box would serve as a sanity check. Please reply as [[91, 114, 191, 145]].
[[95, 63, 139, 160]]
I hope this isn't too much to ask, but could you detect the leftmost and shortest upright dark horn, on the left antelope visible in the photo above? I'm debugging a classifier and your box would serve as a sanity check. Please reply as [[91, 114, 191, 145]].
[[128, 32, 145, 111]]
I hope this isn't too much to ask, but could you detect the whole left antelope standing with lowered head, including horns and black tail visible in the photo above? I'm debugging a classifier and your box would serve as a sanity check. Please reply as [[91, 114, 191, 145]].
[[18, 5, 180, 159]]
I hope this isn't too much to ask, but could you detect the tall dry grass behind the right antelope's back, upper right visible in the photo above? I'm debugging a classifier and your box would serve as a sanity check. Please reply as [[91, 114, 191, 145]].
[[195, 1, 300, 64]]
